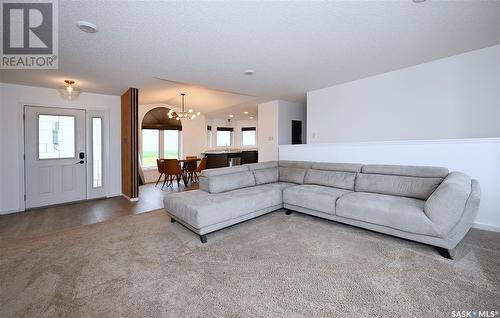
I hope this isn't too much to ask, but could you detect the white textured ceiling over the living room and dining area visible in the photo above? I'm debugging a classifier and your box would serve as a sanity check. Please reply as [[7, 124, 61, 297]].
[[1, 0, 500, 116]]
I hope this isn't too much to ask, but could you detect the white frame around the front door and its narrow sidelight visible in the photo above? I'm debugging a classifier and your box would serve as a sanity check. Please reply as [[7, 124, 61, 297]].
[[17, 102, 110, 211]]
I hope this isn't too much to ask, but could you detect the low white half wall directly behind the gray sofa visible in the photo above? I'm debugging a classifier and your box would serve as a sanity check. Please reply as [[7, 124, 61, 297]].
[[279, 138, 500, 231]]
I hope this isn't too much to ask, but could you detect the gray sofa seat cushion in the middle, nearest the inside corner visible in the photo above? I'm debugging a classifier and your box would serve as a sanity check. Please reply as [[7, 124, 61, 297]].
[[283, 184, 352, 214]]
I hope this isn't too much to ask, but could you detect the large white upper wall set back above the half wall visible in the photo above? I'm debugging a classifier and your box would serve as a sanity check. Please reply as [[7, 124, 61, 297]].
[[308, 45, 500, 143]]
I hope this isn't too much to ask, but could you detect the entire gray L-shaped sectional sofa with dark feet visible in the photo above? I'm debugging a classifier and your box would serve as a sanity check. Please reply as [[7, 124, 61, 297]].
[[164, 161, 480, 258]]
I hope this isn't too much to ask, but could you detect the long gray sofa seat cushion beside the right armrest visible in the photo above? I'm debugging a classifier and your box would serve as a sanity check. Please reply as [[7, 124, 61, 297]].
[[335, 192, 438, 236]]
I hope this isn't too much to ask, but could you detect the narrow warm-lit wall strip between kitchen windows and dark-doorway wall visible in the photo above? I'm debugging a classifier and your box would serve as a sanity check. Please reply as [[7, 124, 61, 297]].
[[257, 100, 278, 162]]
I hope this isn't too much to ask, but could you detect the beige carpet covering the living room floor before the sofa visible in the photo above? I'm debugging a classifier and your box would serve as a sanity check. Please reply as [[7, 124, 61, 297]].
[[0, 211, 500, 317]]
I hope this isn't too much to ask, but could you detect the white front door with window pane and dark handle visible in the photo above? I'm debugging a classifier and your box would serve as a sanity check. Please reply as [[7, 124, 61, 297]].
[[24, 106, 87, 208]]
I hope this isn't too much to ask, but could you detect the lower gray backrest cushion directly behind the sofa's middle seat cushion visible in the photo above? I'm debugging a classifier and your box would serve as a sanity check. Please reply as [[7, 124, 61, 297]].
[[304, 169, 356, 191]]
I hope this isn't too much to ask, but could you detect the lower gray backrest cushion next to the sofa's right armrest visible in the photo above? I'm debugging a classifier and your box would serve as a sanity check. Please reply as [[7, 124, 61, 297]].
[[354, 173, 443, 200]]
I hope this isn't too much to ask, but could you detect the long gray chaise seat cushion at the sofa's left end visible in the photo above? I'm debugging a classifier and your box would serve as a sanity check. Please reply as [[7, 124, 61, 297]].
[[164, 185, 283, 229]]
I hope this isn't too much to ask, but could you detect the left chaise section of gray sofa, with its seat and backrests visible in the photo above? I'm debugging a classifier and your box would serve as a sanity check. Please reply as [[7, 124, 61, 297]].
[[164, 162, 293, 243]]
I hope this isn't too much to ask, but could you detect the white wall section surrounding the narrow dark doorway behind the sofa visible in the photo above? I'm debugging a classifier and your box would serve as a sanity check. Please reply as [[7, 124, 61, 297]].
[[278, 100, 307, 145]]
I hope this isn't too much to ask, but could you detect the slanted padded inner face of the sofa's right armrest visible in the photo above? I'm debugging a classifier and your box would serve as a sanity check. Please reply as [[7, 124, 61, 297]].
[[424, 172, 472, 237]]
